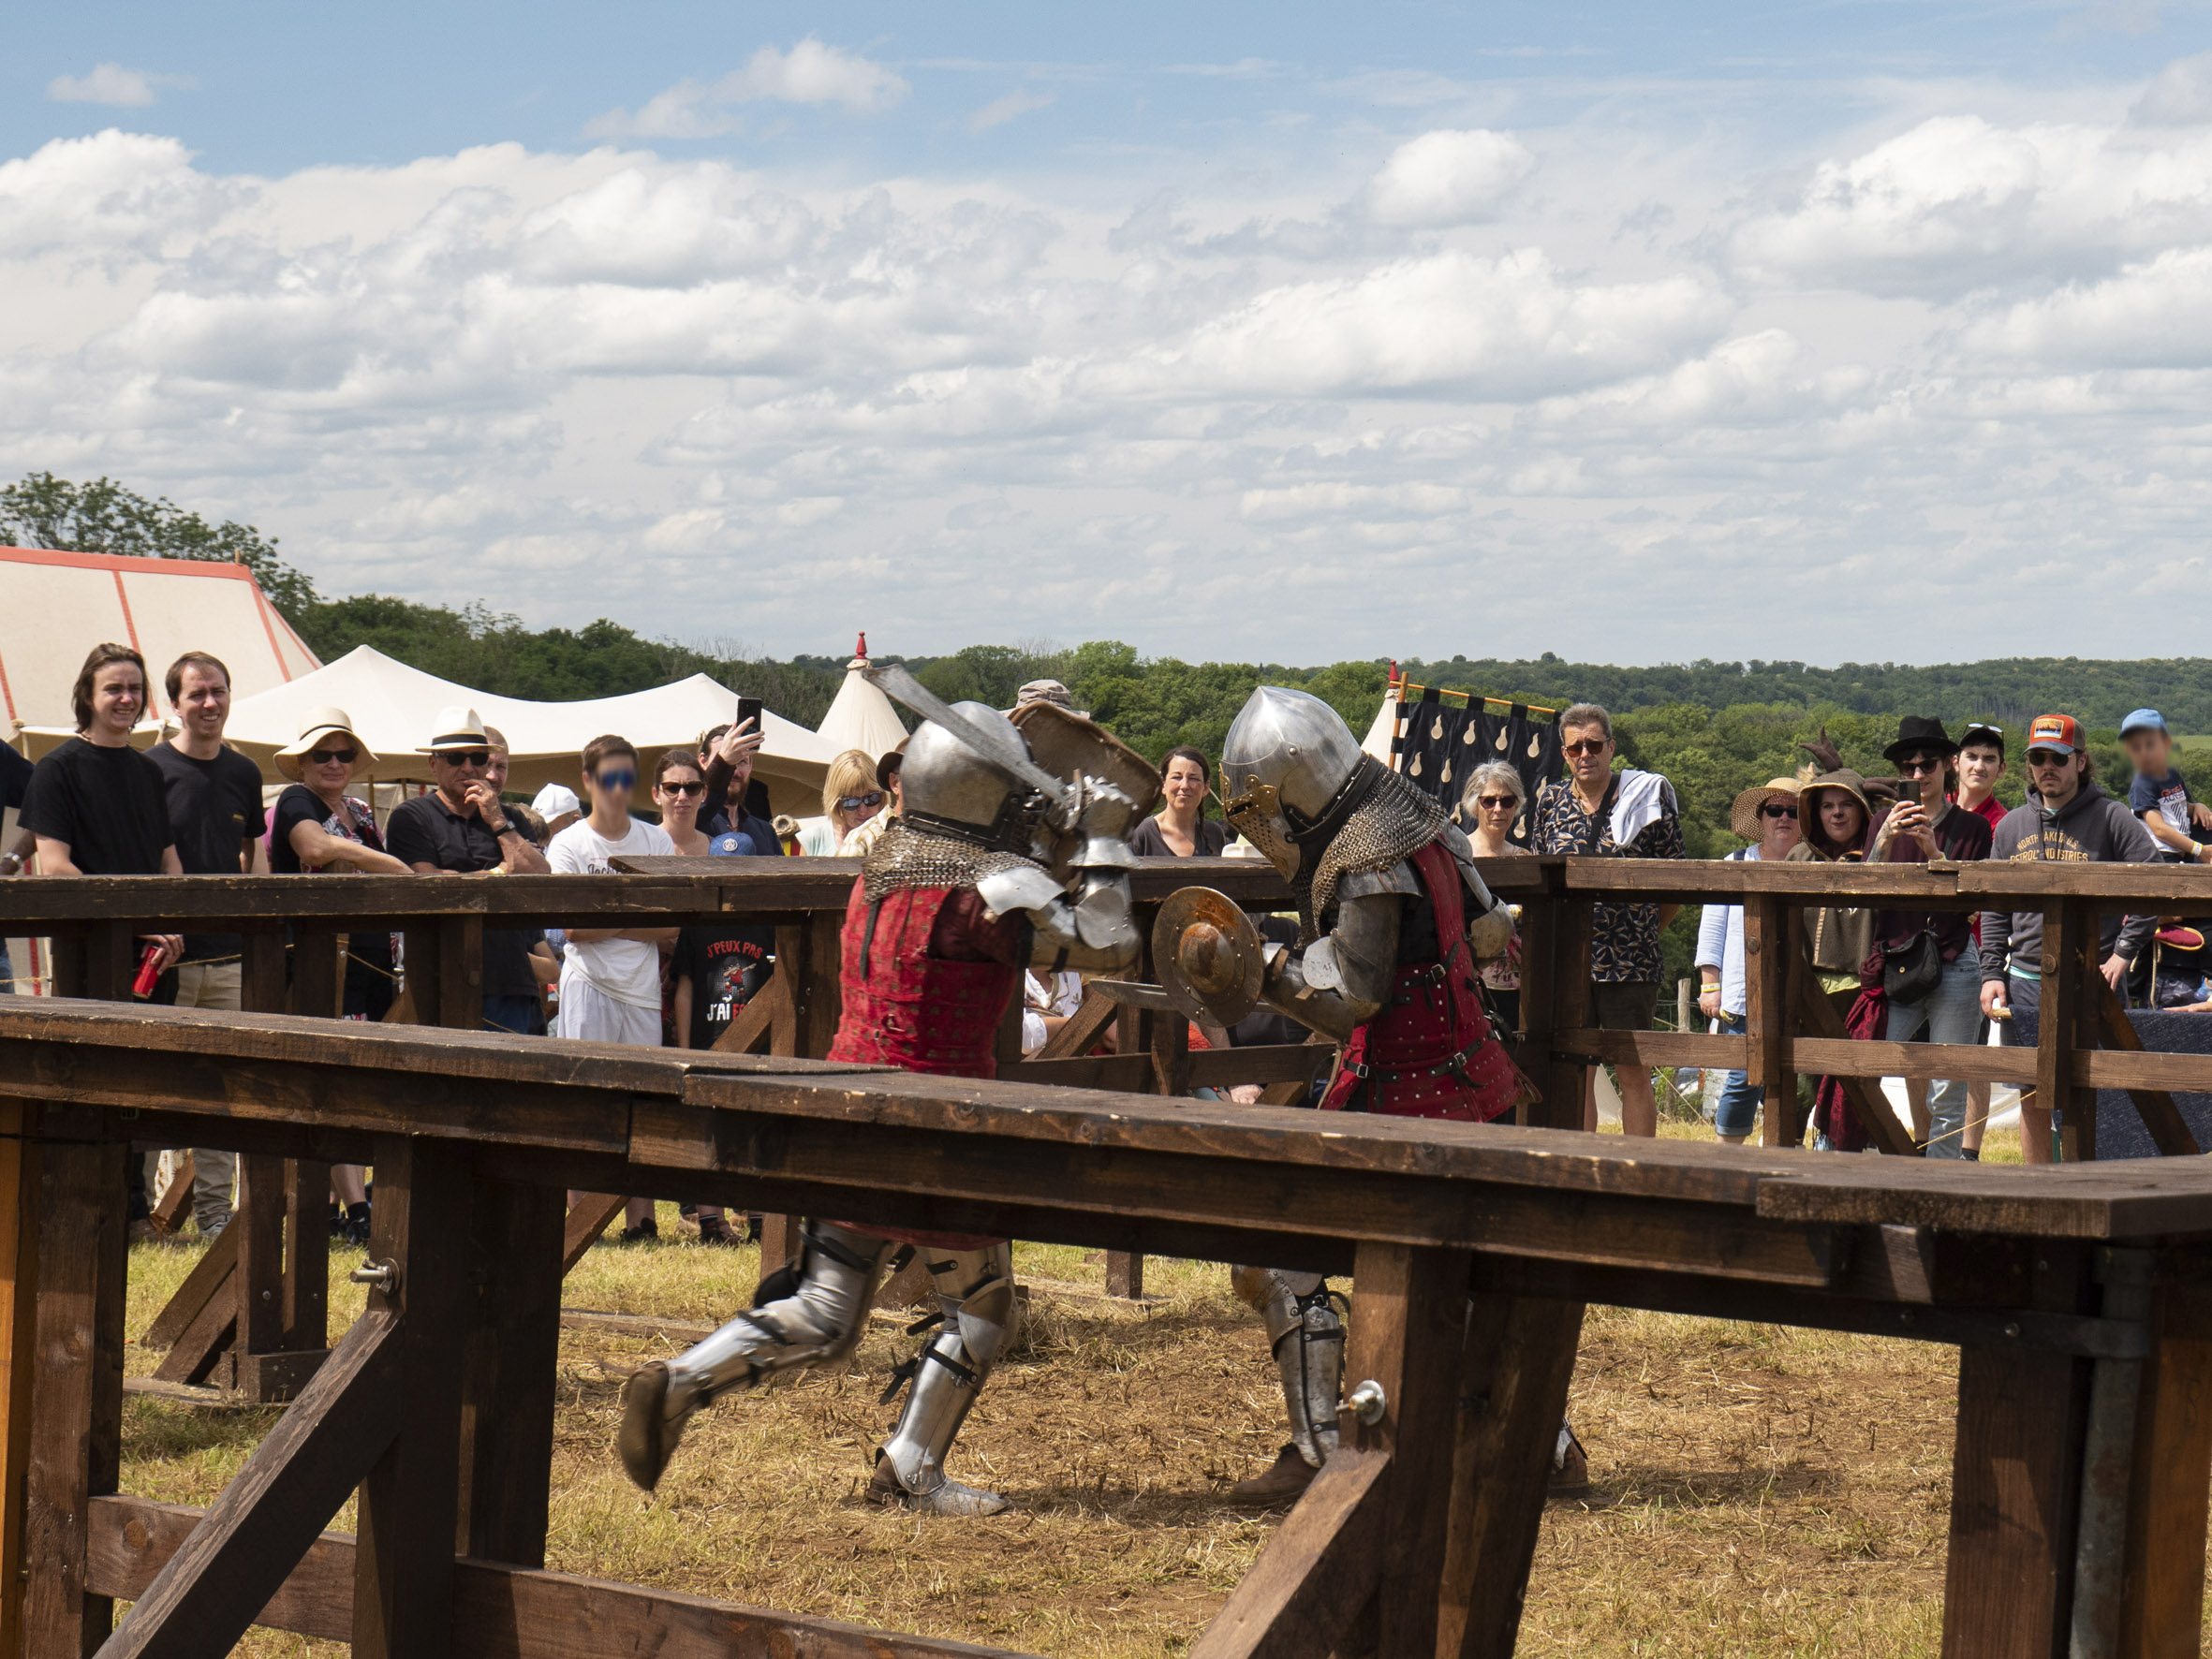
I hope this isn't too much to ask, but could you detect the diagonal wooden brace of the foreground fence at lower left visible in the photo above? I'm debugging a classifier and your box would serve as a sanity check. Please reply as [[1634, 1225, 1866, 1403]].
[[99, 1309, 406, 1659]]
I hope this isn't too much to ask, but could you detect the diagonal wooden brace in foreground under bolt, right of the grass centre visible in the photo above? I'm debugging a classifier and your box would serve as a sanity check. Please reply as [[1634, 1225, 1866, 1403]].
[[1190, 1449, 1389, 1659]]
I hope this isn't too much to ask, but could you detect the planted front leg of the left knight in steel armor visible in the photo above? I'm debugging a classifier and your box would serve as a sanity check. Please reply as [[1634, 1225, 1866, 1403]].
[[869, 1243, 1013, 1515]]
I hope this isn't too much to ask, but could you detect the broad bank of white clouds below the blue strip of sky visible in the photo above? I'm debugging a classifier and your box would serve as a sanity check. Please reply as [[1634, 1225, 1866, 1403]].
[[12, 90, 2212, 659]]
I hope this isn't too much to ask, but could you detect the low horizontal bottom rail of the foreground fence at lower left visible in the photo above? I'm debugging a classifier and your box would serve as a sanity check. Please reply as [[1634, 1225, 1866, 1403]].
[[91, 1504, 1022, 1659]]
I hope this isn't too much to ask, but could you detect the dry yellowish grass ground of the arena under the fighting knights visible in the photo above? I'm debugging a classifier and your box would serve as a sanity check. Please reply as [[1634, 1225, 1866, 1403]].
[[108, 1130, 2141, 1659]]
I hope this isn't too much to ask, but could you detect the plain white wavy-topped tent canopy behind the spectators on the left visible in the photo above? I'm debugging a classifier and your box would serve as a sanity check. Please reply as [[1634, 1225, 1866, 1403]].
[[228, 646, 836, 814]]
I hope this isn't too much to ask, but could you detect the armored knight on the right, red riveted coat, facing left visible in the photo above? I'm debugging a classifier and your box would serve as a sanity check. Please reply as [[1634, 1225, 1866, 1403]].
[[1221, 685, 1533, 1502]]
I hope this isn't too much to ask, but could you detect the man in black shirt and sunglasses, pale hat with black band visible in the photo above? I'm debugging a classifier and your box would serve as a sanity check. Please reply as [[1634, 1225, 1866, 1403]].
[[385, 708, 551, 1035]]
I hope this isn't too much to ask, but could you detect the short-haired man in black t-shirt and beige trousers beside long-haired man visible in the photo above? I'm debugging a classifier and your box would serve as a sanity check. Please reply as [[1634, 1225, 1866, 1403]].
[[146, 651, 268, 1239]]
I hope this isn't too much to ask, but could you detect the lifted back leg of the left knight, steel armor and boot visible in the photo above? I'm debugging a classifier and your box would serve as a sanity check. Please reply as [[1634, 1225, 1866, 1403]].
[[615, 1221, 892, 1490]]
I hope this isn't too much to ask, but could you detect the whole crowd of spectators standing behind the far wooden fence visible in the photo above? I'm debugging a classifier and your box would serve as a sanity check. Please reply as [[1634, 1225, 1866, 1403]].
[[0, 644, 2212, 1243]]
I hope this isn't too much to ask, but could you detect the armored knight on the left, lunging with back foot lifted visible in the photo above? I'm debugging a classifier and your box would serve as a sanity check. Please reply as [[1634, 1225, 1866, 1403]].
[[617, 703, 1142, 1515]]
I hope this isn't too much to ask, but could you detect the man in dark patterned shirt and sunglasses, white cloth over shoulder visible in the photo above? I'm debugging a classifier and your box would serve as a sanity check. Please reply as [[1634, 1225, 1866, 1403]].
[[1535, 703, 1683, 1135]]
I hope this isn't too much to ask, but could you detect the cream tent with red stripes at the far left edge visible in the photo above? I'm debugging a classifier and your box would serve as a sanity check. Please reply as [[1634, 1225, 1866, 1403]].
[[0, 547, 320, 758]]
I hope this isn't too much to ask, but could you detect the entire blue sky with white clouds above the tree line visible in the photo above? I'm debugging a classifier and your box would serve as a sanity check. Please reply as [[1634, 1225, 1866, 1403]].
[[0, 0, 2212, 664]]
